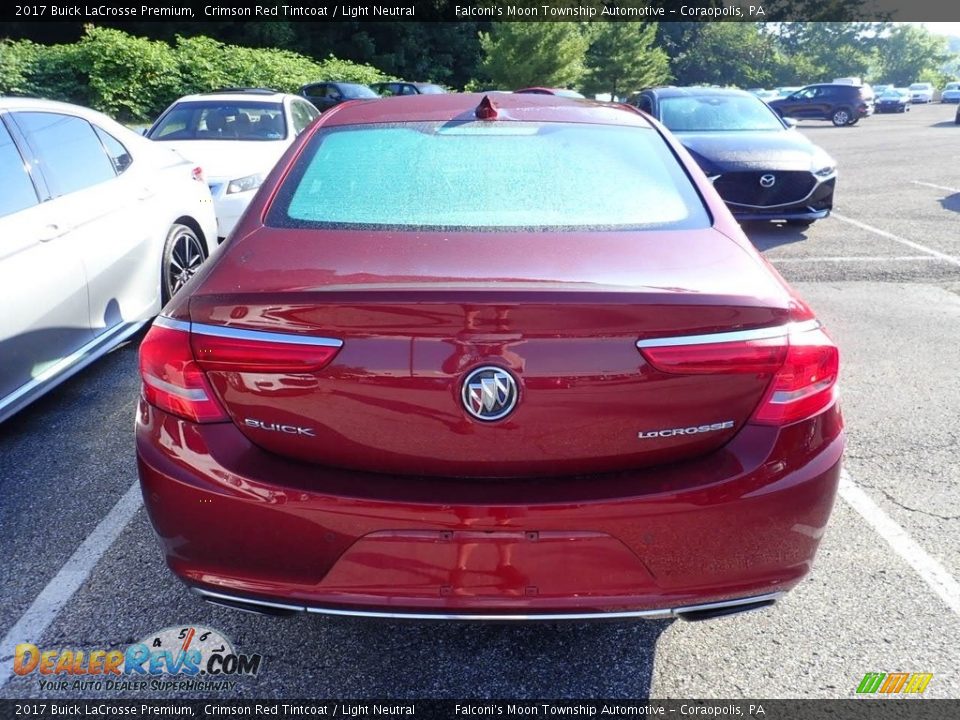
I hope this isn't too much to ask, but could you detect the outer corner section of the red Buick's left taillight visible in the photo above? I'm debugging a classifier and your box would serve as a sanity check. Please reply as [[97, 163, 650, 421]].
[[140, 317, 229, 423]]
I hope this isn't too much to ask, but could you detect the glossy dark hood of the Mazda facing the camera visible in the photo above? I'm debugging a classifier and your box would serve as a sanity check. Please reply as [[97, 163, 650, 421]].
[[674, 130, 816, 175]]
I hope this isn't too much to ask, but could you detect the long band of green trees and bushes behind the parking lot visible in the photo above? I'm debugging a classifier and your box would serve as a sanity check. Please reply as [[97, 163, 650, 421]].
[[0, 19, 960, 120]]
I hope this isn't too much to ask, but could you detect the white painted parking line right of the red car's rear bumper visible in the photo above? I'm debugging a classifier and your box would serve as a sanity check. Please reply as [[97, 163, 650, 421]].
[[840, 470, 960, 615]]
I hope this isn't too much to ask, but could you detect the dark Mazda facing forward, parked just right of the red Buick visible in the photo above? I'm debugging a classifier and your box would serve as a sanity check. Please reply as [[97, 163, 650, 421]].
[[638, 87, 837, 225]]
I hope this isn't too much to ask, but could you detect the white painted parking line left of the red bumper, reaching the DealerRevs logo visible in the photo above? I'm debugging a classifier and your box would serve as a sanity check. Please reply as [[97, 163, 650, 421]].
[[0, 482, 141, 688]]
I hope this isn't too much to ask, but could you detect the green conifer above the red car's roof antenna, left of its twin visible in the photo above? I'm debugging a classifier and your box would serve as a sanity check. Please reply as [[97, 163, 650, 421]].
[[480, 22, 587, 89]]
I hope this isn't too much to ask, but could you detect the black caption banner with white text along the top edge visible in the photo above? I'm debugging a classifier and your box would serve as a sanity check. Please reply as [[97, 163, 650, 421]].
[[0, 0, 960, 24]]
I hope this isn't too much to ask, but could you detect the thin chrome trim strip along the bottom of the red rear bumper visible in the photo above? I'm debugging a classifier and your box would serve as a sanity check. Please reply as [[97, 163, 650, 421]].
[[190, 587, 784, 622]]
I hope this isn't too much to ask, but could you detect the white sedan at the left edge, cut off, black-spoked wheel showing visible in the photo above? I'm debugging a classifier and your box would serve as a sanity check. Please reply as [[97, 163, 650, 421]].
[[0, 97, 217, 421]]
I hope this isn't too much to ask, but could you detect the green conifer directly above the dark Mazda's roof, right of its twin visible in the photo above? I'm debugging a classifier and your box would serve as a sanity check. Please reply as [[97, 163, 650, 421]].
[[583, 22, 670, 99]]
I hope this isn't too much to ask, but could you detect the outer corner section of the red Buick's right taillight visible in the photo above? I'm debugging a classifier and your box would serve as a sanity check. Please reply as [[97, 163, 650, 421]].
[[752, 328, 840, 425]]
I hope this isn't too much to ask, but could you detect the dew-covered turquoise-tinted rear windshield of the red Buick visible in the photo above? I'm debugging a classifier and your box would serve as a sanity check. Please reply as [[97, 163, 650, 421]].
[[267, 121, 710, 230]]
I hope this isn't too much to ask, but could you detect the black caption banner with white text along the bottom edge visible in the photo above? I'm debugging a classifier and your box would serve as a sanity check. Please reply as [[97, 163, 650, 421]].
[[0, 698, 960, 720]]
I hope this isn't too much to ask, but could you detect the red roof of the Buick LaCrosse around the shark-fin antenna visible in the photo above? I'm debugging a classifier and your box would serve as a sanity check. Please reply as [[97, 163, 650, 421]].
[[322, 92, 650, 127]]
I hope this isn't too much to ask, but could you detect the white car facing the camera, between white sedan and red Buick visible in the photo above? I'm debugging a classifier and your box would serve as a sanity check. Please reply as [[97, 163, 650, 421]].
[[147, 88, 320, 239]]
